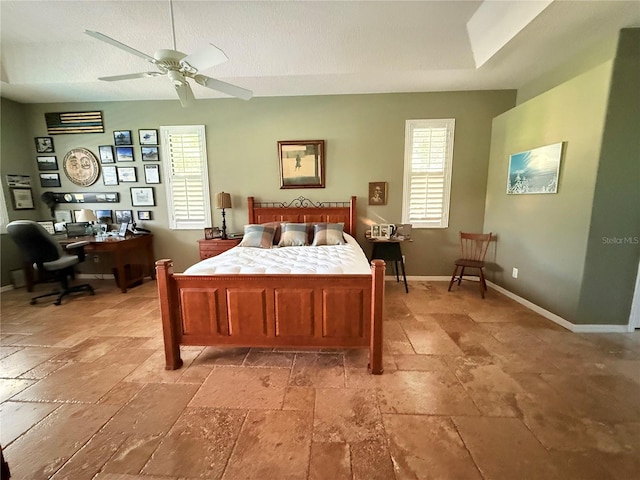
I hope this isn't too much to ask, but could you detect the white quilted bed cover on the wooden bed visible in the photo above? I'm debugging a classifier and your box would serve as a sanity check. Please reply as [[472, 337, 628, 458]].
[[184, 233, 371, 275]]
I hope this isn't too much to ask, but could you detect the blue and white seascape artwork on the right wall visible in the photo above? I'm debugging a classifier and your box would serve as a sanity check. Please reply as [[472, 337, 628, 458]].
[[507, 142, 564, 195]]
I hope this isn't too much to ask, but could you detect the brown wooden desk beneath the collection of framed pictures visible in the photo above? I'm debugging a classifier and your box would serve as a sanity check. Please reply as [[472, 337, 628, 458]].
[[25, 235, 156, 293]]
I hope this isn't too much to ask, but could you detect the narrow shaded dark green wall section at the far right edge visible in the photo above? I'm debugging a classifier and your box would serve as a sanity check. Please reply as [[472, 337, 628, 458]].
[[577, 29, 640, 324]]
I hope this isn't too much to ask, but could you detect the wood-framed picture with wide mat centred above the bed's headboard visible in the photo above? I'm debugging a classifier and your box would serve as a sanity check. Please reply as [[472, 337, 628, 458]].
[[278, 140, 325, 188]]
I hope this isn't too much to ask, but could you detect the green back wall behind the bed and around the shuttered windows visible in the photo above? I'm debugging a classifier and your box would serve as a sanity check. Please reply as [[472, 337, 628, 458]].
[[1, 90, 515, 282]]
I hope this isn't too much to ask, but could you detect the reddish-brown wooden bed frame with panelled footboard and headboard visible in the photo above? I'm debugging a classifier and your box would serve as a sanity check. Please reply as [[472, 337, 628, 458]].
[[156, 197, 385, 374]]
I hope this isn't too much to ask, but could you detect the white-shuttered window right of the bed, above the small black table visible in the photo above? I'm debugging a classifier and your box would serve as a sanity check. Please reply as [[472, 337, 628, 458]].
[[402, 118, 455, 228]]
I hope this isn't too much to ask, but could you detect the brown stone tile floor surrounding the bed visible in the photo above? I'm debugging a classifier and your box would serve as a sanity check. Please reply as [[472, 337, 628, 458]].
[[0, 281, 640, 480]]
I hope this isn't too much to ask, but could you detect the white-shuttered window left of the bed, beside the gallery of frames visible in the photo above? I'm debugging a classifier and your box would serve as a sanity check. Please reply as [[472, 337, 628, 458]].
[[160, 125, 211, 230]]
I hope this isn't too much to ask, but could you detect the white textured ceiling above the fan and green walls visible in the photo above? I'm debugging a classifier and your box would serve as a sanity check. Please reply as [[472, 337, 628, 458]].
[[0, 0, 640, 103]]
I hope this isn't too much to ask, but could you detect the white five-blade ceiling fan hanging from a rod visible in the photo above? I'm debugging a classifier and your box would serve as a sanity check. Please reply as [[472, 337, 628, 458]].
[[84, 0, 253, 107]]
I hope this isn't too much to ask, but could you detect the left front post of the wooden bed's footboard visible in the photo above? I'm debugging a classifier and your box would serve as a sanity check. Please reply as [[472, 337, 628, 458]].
[[156, 259, 182, 370]]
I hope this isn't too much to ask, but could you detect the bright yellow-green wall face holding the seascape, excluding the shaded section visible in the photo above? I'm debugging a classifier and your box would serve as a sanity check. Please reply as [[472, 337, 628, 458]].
[[484, 62, 611, 322]]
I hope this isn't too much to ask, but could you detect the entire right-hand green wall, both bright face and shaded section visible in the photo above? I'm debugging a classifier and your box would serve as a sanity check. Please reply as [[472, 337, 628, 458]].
[[484, 29, 640, 325]]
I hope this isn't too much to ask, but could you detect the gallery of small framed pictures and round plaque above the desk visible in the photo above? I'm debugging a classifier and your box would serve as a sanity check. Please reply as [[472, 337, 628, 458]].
[[21, 128, 161, 223]]
